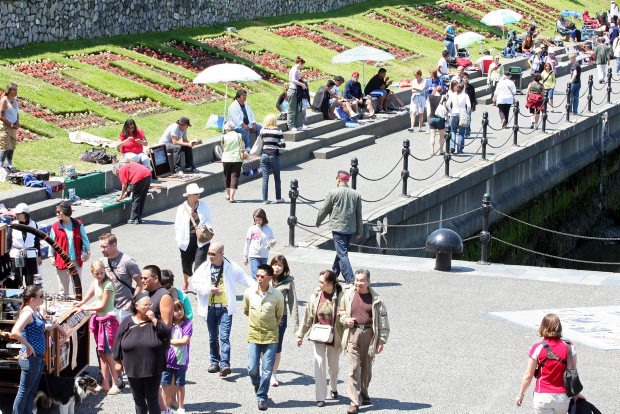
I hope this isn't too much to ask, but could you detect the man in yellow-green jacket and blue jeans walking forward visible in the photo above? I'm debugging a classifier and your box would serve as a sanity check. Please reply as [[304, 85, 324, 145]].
[[243, 264, 284, 411]]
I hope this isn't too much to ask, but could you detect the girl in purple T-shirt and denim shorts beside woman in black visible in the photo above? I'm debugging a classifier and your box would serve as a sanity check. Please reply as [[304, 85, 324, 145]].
[[161, 300, 193, 414]]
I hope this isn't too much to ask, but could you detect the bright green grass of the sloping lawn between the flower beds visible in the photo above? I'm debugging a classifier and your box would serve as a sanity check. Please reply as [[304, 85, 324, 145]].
[[0, 0, 608, 183]]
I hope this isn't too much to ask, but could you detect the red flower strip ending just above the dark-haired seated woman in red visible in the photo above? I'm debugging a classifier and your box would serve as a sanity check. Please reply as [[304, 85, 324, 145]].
[[11, 60, 170, 116]]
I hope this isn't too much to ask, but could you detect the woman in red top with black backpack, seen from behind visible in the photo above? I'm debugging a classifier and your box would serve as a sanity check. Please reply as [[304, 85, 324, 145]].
[[517, 313, 583, 414]]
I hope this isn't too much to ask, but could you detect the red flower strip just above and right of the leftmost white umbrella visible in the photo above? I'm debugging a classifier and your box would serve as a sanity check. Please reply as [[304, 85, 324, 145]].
[[201, 35, 328, 82]]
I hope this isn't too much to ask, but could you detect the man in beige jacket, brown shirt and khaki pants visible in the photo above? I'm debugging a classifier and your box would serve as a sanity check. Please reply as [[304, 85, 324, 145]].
[[340, 269, 390, 414]]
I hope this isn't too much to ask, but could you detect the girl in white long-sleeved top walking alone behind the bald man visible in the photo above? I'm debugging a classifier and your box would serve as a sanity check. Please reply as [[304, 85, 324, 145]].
[[243, 208, 276, 280]]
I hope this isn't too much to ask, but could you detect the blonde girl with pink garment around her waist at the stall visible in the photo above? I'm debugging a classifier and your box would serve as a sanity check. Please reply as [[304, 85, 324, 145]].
[[73, 260, 121, 395]]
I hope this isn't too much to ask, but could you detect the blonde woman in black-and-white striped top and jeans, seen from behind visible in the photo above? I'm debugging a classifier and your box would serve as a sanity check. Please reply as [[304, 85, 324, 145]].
[[259, 114, 286, 204]]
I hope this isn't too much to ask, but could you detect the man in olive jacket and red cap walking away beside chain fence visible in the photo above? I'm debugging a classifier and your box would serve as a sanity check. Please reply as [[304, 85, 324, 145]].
[[316, 171, 363, 283]]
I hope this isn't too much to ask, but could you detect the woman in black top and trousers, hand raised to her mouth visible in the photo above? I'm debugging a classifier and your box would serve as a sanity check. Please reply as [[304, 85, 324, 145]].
[[114, 292, 170, 414]]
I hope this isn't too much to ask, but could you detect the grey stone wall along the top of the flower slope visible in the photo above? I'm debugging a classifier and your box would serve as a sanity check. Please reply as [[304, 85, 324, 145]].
[[0, 0, 364, 49]]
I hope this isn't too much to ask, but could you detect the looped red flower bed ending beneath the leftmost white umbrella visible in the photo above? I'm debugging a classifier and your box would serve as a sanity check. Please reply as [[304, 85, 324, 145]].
[[71, 52, 219, 104]]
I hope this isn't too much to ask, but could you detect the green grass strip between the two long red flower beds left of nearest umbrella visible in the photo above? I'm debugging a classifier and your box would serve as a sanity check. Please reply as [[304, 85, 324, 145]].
[[57, 58, 189, 109]]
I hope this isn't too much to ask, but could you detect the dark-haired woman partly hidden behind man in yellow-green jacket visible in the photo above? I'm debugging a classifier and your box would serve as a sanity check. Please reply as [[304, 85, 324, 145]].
[[271, 255, 299, 387]]
